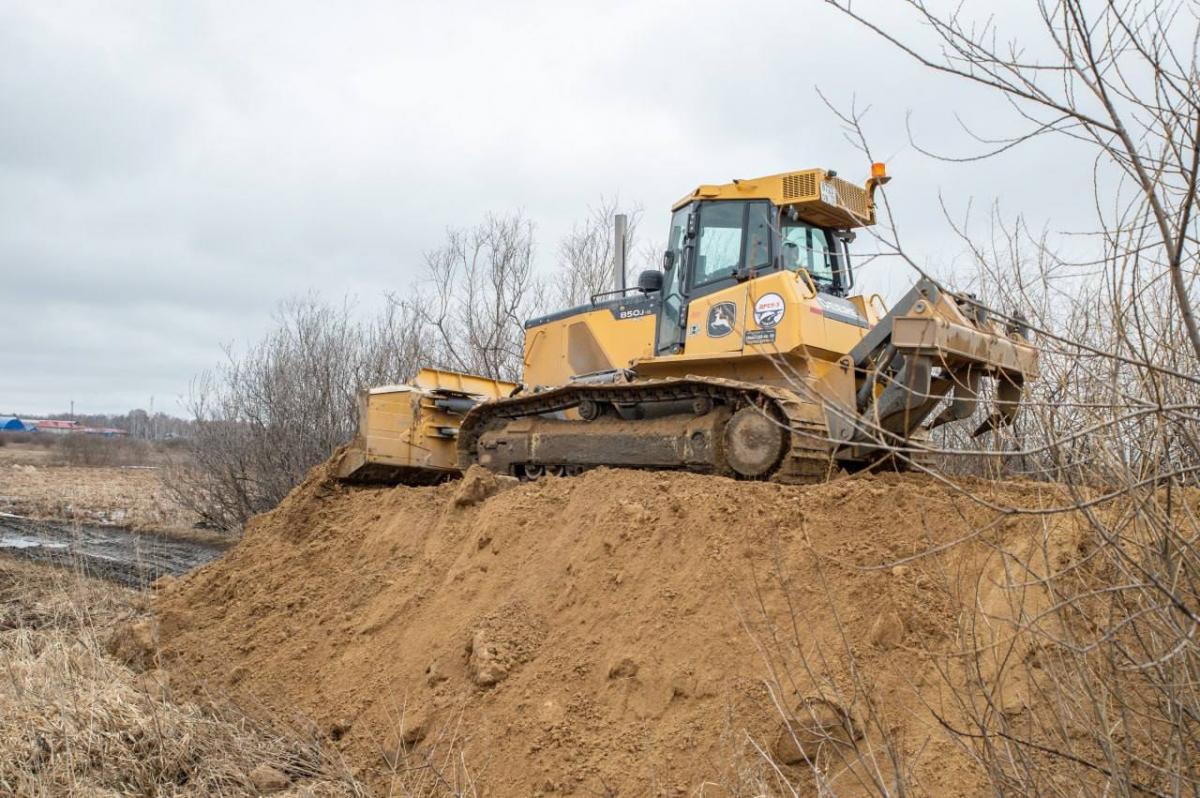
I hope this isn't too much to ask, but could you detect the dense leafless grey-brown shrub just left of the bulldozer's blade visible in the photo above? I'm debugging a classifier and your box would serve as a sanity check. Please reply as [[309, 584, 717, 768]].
[[168, 298, 424, 530]]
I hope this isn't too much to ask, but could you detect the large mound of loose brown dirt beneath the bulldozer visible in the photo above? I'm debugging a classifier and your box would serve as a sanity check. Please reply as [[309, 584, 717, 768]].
[[157, 469, 1073, 796]]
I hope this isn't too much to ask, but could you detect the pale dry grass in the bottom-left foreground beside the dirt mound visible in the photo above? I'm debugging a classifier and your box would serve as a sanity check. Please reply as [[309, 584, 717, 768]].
[[0, 559, 364, 796]]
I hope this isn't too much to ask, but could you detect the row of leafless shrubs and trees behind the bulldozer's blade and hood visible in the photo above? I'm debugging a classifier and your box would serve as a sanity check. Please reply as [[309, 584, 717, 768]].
[[174, 203, 640, 530]]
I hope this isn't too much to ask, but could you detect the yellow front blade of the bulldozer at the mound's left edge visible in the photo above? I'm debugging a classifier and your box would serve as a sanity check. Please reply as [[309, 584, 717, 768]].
[[334, 368, 516, 485]]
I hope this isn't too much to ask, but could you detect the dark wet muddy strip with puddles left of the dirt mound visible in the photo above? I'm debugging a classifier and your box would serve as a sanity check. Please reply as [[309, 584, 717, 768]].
[[0, 515, 224, 587]]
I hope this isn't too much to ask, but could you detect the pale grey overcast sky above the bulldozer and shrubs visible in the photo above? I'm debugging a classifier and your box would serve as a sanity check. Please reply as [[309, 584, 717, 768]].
[[0, 0, 1090, 414]]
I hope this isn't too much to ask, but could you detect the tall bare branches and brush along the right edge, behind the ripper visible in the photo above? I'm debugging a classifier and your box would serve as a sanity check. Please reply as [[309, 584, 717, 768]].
[[748, 0, 1200, 796]]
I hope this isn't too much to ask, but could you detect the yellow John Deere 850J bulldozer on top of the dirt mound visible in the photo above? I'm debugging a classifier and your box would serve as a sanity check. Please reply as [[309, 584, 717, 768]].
[[336, 163, 1038, 484]]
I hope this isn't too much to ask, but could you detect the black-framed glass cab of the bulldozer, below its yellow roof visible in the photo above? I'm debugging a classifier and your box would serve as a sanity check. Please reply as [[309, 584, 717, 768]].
[[654, 199, 852, 355]]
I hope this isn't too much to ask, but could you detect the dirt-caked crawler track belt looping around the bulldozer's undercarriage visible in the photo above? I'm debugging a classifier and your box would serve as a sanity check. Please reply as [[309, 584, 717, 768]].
[[458, 377, 838, 484]]
